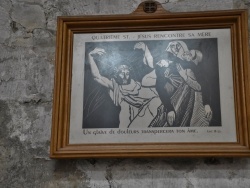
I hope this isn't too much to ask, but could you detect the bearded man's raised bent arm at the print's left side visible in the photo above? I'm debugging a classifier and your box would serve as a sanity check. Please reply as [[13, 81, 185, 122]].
[[88, 48, 113, 89]]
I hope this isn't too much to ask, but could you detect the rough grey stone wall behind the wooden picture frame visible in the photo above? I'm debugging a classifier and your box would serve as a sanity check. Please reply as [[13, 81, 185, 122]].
[[0, 0, 250, 188]]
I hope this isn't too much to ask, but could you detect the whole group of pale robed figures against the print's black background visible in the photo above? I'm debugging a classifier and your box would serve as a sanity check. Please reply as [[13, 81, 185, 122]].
[[88, 40, 213, 128]]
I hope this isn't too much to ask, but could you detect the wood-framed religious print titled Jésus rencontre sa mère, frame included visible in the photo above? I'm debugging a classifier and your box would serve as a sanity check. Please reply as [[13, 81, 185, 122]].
[[50, 3, 250, 158]]
